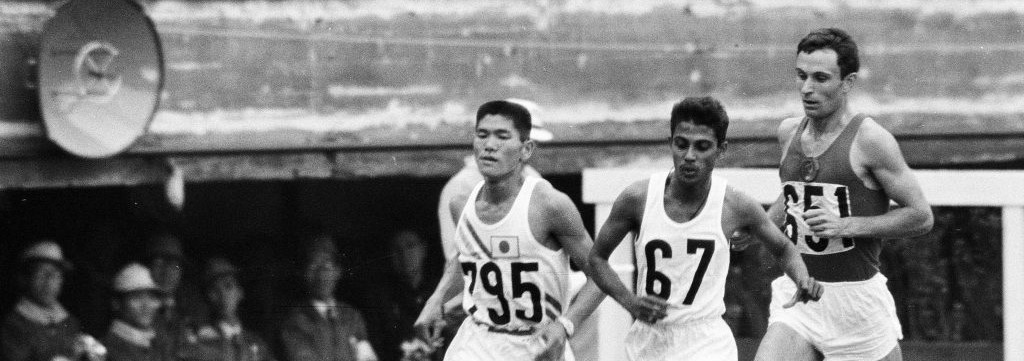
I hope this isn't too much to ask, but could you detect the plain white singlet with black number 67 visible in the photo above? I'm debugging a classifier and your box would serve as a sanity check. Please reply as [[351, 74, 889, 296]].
[[633, 172, 729, 324]]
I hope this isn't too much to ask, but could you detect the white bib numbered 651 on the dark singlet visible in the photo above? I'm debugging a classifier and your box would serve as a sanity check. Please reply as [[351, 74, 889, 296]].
[[782, 181, 855, 255]]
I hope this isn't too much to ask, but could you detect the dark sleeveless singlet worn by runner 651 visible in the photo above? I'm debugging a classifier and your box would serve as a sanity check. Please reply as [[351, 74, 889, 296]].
[[778, 115, 889, 282]]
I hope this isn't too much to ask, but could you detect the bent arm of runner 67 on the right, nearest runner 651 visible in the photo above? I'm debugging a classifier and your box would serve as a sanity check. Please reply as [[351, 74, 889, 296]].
[[728, 187, 823, 302]]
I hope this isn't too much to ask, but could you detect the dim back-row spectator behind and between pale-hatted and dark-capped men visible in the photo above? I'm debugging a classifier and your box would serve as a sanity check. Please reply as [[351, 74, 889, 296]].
[[143, 233, 207, 335]]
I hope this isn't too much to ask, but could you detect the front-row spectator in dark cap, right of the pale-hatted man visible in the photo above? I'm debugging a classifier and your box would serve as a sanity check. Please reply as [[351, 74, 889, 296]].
[[178, 258, 273, 361]]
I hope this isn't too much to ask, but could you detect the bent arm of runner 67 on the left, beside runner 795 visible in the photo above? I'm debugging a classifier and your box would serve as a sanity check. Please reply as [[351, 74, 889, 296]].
[[590, 181, 668, 323]]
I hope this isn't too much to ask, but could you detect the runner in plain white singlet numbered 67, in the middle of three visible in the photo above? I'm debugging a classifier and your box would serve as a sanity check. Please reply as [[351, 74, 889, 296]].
[[590, 97, 821, 361]]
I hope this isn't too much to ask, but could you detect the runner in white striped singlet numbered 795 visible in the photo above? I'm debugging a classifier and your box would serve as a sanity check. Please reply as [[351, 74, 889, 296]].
[[416, 100, 603, 361]]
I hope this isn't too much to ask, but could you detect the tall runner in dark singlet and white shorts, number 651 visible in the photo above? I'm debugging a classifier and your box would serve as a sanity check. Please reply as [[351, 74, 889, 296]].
[[757, 29, 932, 361]]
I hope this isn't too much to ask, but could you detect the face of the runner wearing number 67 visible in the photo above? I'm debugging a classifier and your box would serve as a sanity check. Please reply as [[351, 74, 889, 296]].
[[672, 122, 726, 185]]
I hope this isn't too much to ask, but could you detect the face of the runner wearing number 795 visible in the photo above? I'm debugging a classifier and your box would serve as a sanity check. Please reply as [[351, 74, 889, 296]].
[[473, 115, 534, 177]]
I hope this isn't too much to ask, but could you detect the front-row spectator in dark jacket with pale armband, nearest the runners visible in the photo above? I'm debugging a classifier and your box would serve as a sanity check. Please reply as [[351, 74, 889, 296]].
[[280, 235, 377, 361]]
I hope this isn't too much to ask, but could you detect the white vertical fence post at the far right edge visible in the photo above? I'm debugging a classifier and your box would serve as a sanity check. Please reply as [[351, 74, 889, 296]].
[[1002, 206, 1024, 361]]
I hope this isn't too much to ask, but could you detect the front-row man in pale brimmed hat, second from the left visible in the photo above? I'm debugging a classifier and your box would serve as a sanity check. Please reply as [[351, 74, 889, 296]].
[[103, 263, 173, 361]]
